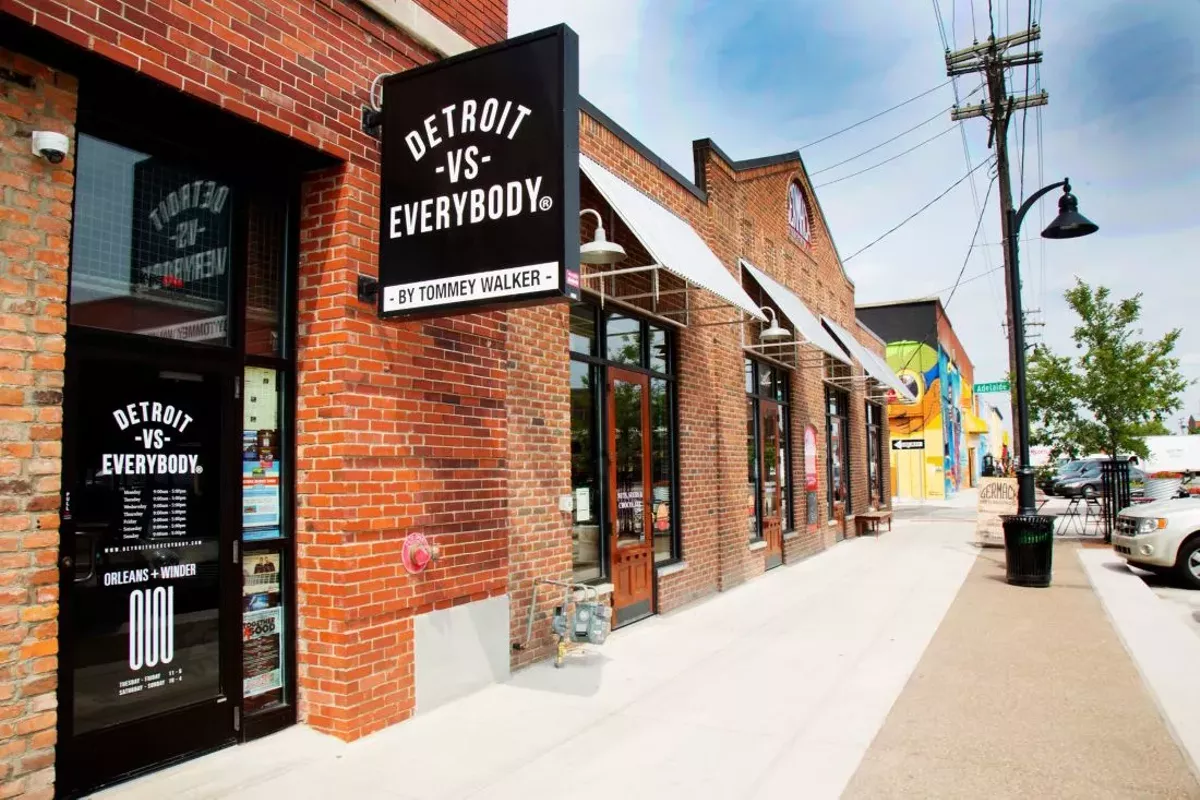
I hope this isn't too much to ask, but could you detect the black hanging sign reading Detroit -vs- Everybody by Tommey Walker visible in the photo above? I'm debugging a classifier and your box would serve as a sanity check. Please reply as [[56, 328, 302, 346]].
[[379, 25, 580, 317]]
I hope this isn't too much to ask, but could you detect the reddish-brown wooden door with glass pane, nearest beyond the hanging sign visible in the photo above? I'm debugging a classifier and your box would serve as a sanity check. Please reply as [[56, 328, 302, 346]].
[[607, 367, 654, 625]]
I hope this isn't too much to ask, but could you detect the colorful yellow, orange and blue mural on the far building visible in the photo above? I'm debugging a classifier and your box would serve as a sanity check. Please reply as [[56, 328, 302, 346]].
[[888, 342, 977, 499]]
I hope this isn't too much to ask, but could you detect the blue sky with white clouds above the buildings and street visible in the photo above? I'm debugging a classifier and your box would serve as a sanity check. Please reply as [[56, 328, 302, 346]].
[[509, 0, 1200, 429]]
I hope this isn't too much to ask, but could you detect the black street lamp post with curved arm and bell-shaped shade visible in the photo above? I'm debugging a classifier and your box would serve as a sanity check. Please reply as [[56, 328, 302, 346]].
[[1004, 179, 1099, 516]]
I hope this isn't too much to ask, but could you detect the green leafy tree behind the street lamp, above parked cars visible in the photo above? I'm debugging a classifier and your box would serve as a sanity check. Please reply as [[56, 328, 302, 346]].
[[1028, 278, 1188, 458]]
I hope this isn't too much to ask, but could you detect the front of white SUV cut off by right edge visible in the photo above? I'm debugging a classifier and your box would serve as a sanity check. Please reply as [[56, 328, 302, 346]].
[[1112, 498, 1200, 589]]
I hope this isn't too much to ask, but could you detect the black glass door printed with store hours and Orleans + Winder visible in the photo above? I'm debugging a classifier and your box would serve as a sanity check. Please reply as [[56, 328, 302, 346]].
[[58, 345, 240, 793]]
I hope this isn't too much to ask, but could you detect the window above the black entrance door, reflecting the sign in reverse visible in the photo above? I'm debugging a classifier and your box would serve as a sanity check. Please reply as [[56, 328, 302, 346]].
[[70, 133, 229, 344]]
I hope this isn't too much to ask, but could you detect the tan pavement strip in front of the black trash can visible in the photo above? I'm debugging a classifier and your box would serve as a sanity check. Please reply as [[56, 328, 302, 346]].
[[845, 543, 1200, 798]]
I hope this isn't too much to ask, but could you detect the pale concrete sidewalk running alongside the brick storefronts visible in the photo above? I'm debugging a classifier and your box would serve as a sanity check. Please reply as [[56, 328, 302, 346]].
[[97, 515, 976, 800]]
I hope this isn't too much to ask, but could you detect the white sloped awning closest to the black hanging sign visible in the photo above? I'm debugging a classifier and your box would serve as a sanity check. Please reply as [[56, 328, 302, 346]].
[[580, 155, 766, 319]]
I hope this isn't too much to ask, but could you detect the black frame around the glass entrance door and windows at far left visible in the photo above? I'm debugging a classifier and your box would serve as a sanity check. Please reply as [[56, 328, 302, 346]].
[[56, 64, 309, 796]]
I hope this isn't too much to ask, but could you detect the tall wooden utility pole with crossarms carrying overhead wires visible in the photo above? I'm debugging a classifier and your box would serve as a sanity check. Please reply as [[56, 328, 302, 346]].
[[946, 25, 1049, 460]]
